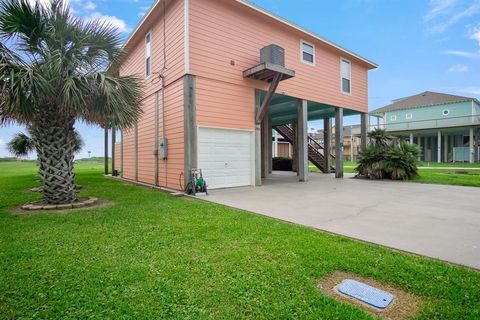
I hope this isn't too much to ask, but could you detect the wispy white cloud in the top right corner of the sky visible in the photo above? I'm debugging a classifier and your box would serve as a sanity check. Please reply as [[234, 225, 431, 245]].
[[424, 0, 480, 33]]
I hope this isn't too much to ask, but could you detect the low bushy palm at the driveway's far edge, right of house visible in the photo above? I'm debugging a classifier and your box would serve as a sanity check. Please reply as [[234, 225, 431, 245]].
[[355, 129, 420, 180]]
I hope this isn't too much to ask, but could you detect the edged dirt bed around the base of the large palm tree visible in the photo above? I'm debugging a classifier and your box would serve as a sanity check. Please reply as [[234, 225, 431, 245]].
[[13, 197, 112, 214]]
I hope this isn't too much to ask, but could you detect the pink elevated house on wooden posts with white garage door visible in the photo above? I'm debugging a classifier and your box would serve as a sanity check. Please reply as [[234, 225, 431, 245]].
[[110, 0, 377, 190]]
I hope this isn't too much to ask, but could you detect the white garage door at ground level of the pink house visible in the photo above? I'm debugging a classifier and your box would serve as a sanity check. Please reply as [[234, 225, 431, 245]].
[[198, 128, 254, 189]]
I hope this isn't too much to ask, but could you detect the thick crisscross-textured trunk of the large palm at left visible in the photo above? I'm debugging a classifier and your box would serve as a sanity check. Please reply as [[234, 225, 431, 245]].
[[31, 114, 77, 204]]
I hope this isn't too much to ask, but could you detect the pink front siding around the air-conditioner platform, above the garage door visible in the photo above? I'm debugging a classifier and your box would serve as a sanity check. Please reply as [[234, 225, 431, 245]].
[[189, 0, 369, 129]]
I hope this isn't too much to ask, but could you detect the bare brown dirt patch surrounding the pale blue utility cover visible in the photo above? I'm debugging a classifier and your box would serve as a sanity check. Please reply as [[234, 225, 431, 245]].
[[318, 271, 421, 320]]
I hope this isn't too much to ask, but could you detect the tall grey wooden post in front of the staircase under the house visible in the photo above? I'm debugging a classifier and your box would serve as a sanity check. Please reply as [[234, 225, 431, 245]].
[[297, 100, 308, 182]]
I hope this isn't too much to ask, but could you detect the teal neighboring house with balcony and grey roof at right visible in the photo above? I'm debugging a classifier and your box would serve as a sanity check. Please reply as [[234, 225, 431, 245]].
[[371, 91, 480, 162]]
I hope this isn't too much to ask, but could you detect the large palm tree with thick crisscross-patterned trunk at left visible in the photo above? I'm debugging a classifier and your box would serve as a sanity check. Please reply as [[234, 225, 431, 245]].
[[0, 0, 142, 204]]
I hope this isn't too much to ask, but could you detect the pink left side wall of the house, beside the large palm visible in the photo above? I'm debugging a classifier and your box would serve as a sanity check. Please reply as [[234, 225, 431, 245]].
[[117, 0, 185, 189]]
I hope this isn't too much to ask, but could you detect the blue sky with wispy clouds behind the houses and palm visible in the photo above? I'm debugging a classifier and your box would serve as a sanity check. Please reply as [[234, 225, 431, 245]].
[[0, 0, 480, 158]]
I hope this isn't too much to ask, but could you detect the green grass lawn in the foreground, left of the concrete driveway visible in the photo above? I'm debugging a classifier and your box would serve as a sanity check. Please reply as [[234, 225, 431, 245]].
[[0, 161, 480, 319]]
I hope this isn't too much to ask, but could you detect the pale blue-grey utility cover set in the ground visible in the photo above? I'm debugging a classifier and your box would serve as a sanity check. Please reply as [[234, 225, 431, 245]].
[[337, 279, 393, 309]]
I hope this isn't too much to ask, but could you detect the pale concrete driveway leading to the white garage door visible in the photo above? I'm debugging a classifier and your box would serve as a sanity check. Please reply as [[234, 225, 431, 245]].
[[204, 172, 480, 269]]
